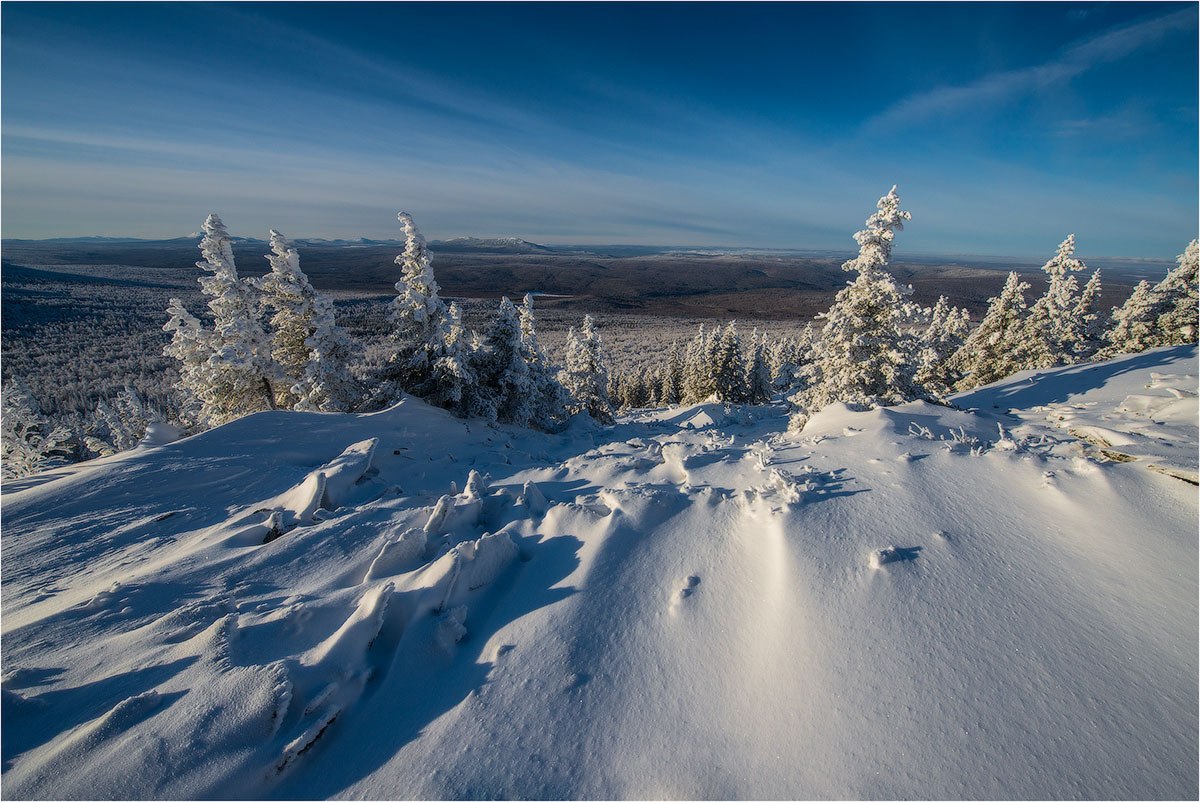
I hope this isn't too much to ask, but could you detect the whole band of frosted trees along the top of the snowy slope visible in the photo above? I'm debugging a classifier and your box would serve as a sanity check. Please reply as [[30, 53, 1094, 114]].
[[4, 187, 1198, 478]]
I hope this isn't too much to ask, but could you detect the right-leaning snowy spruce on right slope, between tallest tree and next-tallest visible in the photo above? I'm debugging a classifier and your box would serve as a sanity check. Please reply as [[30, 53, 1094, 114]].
[[950, 273, 1030, 390]]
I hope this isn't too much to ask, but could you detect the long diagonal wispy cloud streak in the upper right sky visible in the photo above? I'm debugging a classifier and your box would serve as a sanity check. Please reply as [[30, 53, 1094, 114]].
[[864, 6, 1196, 130]]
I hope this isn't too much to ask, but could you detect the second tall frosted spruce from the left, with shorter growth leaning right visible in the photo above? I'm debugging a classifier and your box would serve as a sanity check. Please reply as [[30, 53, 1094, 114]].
[[256, 229, 358, 412]]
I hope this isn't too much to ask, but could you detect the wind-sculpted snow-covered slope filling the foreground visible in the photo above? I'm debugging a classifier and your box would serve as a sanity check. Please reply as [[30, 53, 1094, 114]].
[[2, 347, 1198, 798]]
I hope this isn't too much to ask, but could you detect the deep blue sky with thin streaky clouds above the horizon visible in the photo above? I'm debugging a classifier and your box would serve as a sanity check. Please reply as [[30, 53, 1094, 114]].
[[0, 2, 1200, 258]]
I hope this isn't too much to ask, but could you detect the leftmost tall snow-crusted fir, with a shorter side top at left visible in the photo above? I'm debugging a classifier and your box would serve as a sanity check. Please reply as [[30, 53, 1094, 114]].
[[163, 214, 280, 425]]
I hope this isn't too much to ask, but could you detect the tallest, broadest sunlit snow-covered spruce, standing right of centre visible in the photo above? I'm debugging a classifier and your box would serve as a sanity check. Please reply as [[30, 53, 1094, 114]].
[[800, 186, 924, 409]]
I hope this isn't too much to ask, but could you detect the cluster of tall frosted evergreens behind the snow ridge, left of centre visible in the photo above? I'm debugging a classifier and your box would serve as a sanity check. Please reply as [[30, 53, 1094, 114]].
[[163, 213, 585, 431]]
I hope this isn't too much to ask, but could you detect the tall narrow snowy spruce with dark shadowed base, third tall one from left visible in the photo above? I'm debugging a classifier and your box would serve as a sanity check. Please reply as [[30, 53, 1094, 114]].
[[371, 211, 448, 405]]
